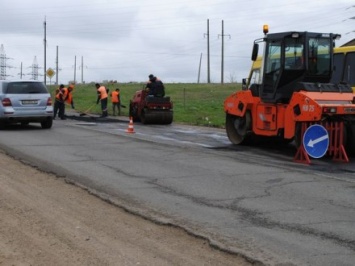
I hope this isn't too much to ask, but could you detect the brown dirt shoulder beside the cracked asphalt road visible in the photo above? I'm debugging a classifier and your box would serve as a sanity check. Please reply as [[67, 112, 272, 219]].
[[0, 151, 251, 266]]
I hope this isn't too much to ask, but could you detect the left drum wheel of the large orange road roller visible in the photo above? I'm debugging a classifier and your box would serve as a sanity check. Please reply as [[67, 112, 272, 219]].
[[226, 111, 251, 145]]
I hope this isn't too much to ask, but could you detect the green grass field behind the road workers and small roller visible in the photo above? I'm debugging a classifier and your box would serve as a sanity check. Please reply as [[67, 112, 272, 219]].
[[48, 83, 241, 127]]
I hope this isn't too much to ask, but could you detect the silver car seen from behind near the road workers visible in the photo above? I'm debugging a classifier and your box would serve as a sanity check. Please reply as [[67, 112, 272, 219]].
[[0, 80, 53, 128]]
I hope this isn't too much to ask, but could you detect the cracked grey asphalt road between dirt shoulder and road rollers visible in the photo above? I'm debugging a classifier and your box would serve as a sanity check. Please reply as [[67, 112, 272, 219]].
[[0, 117, 355, 265]]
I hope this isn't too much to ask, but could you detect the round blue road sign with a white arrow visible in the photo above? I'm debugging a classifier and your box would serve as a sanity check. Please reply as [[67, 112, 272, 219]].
[[303, 125, 329, 159]]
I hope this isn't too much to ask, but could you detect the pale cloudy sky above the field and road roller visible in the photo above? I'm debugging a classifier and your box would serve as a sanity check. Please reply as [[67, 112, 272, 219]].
[[0, 0, 355, 84]]
